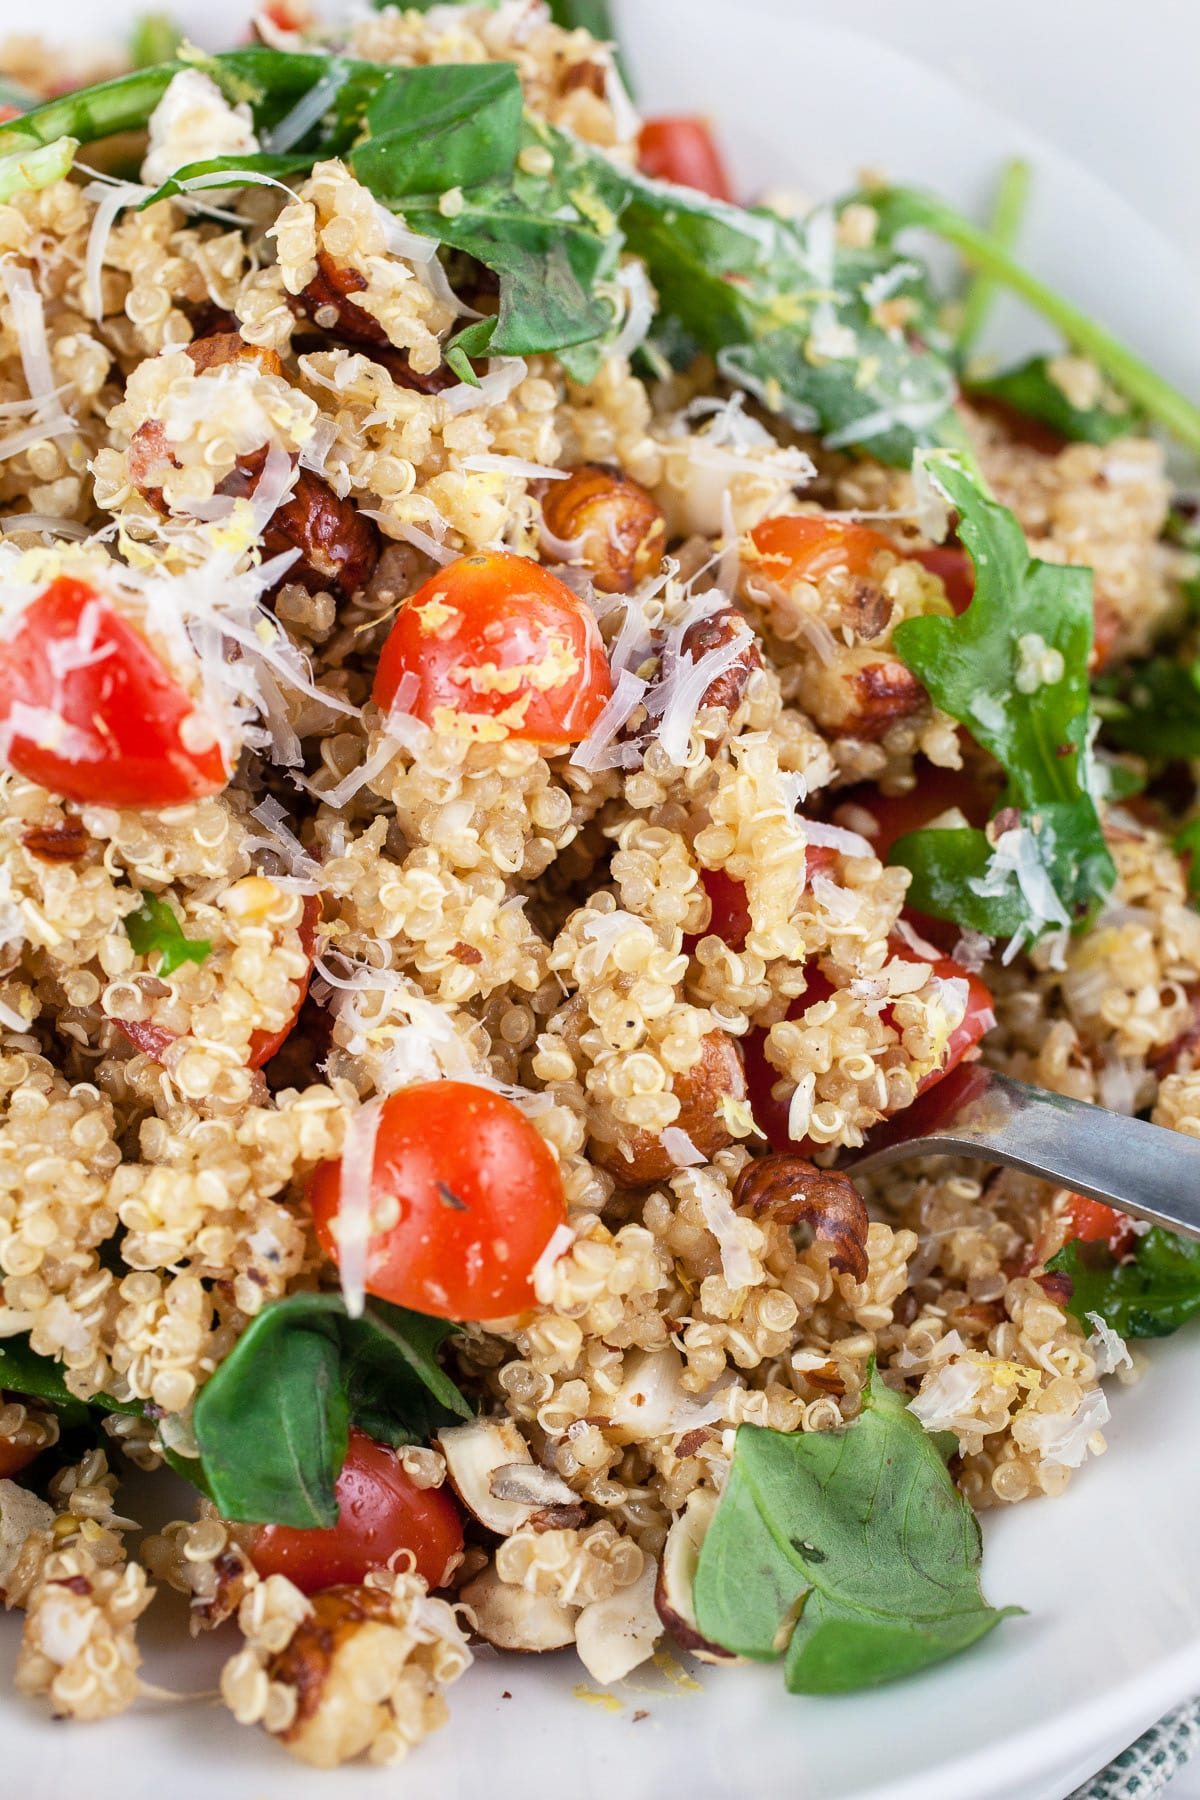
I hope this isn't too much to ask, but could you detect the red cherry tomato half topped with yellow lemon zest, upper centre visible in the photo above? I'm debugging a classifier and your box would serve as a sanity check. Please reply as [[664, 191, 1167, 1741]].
[[372, 551, 612, 743]]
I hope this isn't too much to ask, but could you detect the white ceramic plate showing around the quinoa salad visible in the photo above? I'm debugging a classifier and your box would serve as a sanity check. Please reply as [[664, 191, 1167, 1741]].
[[0, 0, 1200, 1800]]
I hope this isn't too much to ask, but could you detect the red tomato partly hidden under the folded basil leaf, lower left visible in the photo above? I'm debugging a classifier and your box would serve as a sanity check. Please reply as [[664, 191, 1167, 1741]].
[[250, 1426, 462, 1593]]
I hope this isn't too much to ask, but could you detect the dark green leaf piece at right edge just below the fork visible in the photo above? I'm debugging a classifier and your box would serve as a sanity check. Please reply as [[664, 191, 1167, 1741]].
[[1045, 1226, 1200, 1337]]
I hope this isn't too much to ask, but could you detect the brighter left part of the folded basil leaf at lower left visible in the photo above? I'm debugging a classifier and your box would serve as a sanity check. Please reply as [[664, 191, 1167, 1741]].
[[193, 1294, 351, 1528]]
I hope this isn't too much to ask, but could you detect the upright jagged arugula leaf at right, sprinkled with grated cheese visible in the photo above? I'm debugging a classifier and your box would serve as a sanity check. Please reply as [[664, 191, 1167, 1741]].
[[889, 452, 1115, 936]]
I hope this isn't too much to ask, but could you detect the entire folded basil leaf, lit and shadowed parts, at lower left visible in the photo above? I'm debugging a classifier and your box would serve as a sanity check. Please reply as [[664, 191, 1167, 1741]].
[[193, 1294, 471, 1528]]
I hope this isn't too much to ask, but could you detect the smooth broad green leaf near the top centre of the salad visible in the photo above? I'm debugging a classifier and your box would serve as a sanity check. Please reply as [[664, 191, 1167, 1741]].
[[351, 63, 524, 205]]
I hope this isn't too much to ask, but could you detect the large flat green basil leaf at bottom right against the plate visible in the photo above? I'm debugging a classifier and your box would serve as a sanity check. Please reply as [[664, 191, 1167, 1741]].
[[694, 1368, 1020, 1694]]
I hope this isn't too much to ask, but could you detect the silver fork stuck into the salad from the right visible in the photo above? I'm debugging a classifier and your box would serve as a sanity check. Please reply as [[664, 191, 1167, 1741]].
[[838, 1062, 1200, 1238]]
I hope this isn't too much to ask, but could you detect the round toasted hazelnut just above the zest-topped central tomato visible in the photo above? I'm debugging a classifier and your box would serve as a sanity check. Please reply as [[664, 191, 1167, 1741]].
[[542, 463, 667, 594]]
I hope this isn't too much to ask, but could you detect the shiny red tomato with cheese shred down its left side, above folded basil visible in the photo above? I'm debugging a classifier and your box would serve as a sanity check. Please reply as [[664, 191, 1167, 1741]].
[[308, 1082, 567, 1319]]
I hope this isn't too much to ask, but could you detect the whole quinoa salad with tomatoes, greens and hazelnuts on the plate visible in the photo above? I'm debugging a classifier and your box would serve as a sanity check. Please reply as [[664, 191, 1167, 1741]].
[[0, 0, 1200, 1768]]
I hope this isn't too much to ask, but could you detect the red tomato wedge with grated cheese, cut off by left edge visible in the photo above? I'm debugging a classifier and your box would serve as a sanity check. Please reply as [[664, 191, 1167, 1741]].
[[0, 576, 228, 806]]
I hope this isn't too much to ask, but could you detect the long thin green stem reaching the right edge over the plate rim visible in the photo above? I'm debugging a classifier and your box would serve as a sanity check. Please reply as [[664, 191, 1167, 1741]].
[[865, 187, 1200, 455]]
